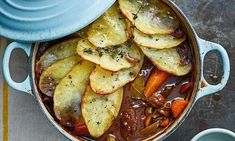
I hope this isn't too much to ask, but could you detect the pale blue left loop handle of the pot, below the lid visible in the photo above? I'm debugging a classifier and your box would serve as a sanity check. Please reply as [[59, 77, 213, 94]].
[[2, 42, 33, 96]]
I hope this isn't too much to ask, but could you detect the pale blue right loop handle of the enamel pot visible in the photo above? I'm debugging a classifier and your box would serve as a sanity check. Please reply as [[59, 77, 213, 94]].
[[196, 38, 230, 100]]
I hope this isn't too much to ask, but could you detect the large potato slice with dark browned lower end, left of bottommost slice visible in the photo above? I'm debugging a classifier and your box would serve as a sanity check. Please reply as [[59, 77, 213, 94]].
[[53, 61, 95, 125]]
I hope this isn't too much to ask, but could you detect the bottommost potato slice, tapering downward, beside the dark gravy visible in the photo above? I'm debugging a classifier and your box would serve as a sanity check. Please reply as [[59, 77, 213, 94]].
[[82, 86, 123, 137]]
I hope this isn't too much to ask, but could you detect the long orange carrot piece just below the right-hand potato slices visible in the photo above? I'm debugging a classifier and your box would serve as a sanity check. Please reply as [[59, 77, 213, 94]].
[[144, 68, 170, 98]]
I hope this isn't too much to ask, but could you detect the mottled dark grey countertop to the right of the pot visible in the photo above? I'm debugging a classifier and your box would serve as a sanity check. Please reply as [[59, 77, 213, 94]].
[[166, 0, 235, 141]]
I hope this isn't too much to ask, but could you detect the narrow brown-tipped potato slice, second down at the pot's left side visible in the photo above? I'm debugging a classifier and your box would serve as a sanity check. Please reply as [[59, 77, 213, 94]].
[[39, 55, 82, 97]]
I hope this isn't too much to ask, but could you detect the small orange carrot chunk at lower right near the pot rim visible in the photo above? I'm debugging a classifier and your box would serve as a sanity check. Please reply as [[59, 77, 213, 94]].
[[171, 99, 188, 118]]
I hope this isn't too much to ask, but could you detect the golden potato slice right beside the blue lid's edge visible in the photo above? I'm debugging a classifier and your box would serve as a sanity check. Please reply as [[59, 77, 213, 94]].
[[87, 4, 127, 47]]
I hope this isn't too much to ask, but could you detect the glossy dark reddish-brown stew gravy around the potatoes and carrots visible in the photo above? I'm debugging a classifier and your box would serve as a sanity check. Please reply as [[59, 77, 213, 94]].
[[36, 41, 194, 141]]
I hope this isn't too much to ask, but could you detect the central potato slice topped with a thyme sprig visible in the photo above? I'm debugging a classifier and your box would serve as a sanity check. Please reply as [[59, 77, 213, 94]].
[[77, 39, 141, 71]]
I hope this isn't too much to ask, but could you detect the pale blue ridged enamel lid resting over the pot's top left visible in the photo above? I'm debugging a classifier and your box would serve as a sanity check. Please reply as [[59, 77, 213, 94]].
[[0, 0, 115, 42]]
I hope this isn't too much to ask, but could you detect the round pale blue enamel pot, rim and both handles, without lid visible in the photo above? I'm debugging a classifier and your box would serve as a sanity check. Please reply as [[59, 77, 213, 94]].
[[0, 0, 230, 141]]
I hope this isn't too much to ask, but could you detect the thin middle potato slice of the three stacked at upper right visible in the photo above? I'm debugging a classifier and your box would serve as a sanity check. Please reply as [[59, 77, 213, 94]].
[[133, 29, 185, 49]]
